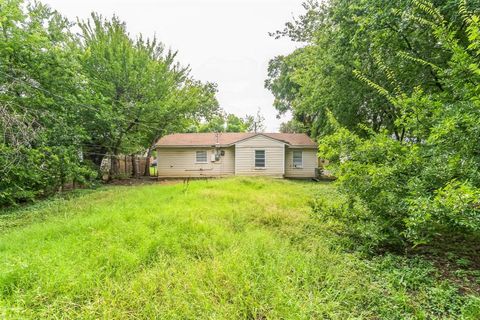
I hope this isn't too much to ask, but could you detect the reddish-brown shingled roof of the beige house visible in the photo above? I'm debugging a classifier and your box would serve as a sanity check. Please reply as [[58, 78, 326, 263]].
[[156, 132, 317, 148]]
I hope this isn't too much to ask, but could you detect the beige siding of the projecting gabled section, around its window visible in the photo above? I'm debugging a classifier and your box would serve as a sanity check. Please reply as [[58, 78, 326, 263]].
[[235, 135, 285, 177]]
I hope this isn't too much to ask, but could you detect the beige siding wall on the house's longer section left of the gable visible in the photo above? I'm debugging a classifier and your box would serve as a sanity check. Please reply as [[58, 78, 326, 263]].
[[157, 147, 235, 178]]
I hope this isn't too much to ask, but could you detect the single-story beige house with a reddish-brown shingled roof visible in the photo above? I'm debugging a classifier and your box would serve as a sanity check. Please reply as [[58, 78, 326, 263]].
[[156, 133, 318, 178]]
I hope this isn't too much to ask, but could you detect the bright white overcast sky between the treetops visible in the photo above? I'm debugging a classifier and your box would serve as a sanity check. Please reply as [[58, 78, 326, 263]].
[[42, 0, 302, 132]]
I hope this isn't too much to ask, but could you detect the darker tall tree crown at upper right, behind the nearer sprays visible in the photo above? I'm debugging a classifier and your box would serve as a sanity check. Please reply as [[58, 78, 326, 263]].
[[266, 0, 480, 140]]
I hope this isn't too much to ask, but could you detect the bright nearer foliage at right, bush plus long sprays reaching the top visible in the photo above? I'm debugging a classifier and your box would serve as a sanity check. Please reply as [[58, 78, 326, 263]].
[[317, 1, 480, 248]]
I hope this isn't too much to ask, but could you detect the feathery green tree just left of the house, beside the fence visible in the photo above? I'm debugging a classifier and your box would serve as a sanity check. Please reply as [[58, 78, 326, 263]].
[[80, 14, 218, 178]]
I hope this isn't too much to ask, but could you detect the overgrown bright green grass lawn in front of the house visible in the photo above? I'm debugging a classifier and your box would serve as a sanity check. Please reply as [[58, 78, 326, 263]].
[[0, 178, 480, 319]]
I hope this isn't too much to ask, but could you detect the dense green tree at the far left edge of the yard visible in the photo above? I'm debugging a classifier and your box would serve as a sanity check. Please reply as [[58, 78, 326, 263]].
[[0, 0, 95, 205]]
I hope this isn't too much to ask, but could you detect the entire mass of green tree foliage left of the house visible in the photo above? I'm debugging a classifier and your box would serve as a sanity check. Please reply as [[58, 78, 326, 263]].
[[0, 0, 218, 206]]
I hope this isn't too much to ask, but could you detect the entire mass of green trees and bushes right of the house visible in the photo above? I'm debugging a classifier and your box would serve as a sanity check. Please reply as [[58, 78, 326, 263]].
[[267, 0, 480, 248]]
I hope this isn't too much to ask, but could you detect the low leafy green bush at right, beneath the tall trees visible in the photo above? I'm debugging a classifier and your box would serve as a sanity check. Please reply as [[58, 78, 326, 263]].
[[314, 120, 480, 248]]
